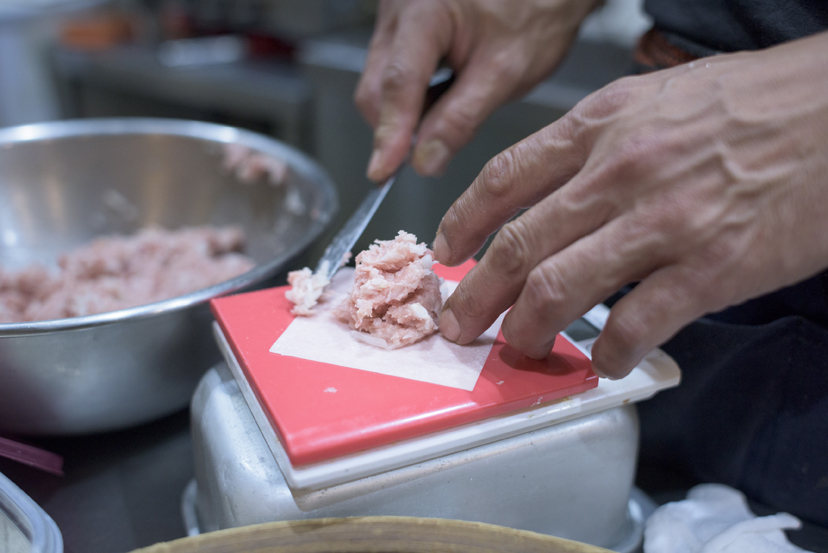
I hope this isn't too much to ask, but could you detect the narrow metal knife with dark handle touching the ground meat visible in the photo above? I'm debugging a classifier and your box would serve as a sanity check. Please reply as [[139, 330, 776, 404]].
[[314, 68, 455, 282]]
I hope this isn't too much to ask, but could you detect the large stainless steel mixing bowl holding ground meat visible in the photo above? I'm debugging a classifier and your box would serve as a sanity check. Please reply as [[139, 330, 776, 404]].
[[0, 119, 337, 434]]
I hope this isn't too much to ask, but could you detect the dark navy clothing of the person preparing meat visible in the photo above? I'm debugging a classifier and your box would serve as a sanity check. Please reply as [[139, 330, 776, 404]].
[[632, 0, 828, 527]]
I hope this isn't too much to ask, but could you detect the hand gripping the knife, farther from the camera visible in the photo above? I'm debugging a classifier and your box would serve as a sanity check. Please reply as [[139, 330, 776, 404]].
[[354, 0, 596, 181]]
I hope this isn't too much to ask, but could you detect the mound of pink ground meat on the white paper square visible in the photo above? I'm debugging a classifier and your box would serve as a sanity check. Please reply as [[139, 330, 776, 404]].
[[336, 231, 443, 349]]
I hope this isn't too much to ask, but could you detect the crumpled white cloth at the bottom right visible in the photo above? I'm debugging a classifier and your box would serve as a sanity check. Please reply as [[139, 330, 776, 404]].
[[644, 484, 805, 553]]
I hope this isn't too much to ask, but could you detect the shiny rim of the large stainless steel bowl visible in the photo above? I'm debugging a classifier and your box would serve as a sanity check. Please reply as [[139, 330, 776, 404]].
[[0, 117, 338, 338]]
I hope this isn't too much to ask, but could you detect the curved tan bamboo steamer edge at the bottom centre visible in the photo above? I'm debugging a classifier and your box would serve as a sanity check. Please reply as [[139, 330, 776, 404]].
[[133, 517, 610, 553]]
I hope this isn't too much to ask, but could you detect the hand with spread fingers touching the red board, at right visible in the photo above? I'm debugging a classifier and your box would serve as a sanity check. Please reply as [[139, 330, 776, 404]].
[[434, 33, 828, 378]]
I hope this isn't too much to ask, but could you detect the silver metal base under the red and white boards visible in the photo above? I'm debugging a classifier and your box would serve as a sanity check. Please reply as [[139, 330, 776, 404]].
[[183, 363, 643, 552]]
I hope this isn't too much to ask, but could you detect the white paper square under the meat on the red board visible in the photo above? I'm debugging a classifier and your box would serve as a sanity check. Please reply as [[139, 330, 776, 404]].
[[270, 269, 503, 391]]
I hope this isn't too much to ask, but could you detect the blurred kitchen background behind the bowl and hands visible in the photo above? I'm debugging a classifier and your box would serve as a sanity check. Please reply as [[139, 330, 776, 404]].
[[0, 0, 648, 260]]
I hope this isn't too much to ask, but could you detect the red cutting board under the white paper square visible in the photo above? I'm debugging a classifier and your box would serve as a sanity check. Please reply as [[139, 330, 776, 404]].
[[210, 262, 598, 466]]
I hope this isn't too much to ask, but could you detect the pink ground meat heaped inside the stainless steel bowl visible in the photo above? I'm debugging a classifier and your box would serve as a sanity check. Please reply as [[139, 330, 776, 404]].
[[0, 226, 255, 323]]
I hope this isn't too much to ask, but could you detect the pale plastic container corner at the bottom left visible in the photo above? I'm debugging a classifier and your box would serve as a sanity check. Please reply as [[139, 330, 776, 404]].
[[0, 474, 63, 553]]
